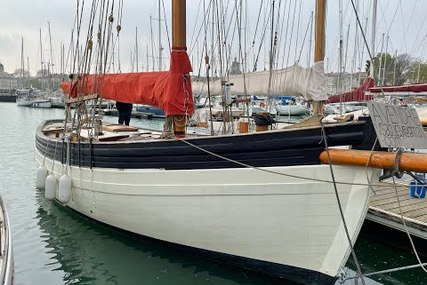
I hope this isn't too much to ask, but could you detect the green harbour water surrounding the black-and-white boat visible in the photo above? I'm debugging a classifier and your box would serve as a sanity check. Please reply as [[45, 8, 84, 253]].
[[0, 103, 427, 285]]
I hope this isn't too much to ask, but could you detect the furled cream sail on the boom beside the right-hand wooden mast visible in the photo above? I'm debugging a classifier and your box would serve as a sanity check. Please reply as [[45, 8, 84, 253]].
[[193, 61, 327, 101]]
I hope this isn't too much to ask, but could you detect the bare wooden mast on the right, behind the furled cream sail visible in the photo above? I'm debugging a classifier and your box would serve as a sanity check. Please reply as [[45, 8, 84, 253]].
[[313, 0, 327, 115]]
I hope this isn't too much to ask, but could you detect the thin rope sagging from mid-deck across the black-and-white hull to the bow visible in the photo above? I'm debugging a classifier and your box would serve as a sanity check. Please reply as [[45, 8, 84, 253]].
[[176, 138, 389, 188]]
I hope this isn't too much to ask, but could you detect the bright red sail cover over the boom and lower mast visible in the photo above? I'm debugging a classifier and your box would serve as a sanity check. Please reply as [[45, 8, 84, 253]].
[[61, 51, 194, 115]]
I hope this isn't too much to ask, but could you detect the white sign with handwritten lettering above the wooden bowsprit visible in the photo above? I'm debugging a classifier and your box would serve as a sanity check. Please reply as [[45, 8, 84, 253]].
[[368, 102, 427, 149]]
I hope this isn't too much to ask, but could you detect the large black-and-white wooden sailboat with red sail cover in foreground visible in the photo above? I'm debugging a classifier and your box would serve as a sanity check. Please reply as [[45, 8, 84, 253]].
[[35, 0, 380, 284]]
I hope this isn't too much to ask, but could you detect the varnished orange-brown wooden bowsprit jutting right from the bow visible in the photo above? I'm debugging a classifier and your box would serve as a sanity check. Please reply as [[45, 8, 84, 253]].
[[319, 149, 427, 172]]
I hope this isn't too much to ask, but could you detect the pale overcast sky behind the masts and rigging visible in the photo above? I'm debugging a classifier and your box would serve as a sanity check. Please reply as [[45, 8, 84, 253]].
[[0, 0, 427, 74]]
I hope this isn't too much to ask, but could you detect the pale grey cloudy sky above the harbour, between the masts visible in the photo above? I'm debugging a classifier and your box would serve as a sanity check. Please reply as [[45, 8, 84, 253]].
[[0, 0, 427, 74]]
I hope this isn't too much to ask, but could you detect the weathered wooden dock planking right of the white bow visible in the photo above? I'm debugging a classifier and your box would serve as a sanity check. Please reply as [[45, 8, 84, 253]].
[[367, 180, 427, 239]]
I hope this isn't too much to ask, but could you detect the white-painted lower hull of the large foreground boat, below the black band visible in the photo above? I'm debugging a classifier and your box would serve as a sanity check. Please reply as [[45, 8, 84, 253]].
[[36, 150, 379, 276]]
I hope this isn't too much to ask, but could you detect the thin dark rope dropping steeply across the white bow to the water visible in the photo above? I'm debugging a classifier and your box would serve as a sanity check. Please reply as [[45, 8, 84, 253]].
[[321, 123, 369, 285]]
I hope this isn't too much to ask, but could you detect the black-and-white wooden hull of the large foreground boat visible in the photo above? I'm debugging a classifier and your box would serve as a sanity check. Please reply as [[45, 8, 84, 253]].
[[36, 116, 379, 284]]
